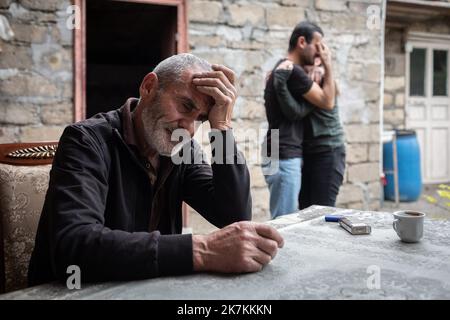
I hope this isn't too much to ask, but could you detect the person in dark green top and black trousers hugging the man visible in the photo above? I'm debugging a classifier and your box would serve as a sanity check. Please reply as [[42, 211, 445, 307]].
[[268, 23, 345, 209]]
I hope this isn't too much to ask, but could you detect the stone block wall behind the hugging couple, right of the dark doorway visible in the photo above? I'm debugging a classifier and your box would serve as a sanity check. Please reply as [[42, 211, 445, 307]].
[[188, 0, 381, 219]]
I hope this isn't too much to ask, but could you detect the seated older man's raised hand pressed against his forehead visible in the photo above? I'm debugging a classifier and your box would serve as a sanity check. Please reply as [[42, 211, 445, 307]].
[[192, 64, 237, 130]]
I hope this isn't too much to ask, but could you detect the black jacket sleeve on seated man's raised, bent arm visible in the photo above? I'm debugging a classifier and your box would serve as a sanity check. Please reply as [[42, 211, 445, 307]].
[[183, 129, 252, 228]]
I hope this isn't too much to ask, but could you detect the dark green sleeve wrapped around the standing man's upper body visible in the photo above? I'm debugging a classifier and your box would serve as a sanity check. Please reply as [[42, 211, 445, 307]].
[[273, 69, 314, 120]]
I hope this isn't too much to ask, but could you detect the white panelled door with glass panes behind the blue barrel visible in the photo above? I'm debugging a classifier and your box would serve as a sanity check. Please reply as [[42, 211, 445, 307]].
[[406, 36, 450, 183]]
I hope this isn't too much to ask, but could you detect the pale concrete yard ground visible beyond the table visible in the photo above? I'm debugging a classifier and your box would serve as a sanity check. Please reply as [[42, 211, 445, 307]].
[[189, 184, 450, 234]]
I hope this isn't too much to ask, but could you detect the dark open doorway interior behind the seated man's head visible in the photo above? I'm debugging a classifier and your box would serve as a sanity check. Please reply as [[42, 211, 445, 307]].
[[85, 0, 177, 118]]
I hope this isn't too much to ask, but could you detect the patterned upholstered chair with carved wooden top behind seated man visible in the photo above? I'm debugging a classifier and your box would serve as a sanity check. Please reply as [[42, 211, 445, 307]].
[[0, 142, 57, 292]]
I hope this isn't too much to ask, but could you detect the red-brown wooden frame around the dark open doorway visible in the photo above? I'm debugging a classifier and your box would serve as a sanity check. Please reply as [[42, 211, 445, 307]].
[[73, 0, 188, 122]]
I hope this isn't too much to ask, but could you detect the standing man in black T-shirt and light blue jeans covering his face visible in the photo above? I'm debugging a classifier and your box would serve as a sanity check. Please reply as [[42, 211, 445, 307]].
[[262, 21, 335, 218]]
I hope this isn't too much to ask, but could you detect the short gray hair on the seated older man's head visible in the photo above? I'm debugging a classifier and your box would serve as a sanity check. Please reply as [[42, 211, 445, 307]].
[[153, 53, 212, 89]]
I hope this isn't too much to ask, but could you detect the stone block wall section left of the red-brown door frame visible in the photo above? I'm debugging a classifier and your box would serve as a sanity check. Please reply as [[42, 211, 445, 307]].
[[0, 0, 73, 143]]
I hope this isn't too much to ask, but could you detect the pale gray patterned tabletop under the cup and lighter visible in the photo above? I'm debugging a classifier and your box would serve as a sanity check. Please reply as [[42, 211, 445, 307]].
[[0, 206, 450, 300]]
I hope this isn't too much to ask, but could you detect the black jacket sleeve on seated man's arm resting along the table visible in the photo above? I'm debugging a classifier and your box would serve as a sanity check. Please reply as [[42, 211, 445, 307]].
[[45, 125, 192, 281]]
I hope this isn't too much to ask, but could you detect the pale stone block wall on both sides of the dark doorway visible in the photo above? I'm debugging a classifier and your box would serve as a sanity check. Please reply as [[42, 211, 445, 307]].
[[0, 0, 382, 225]]
